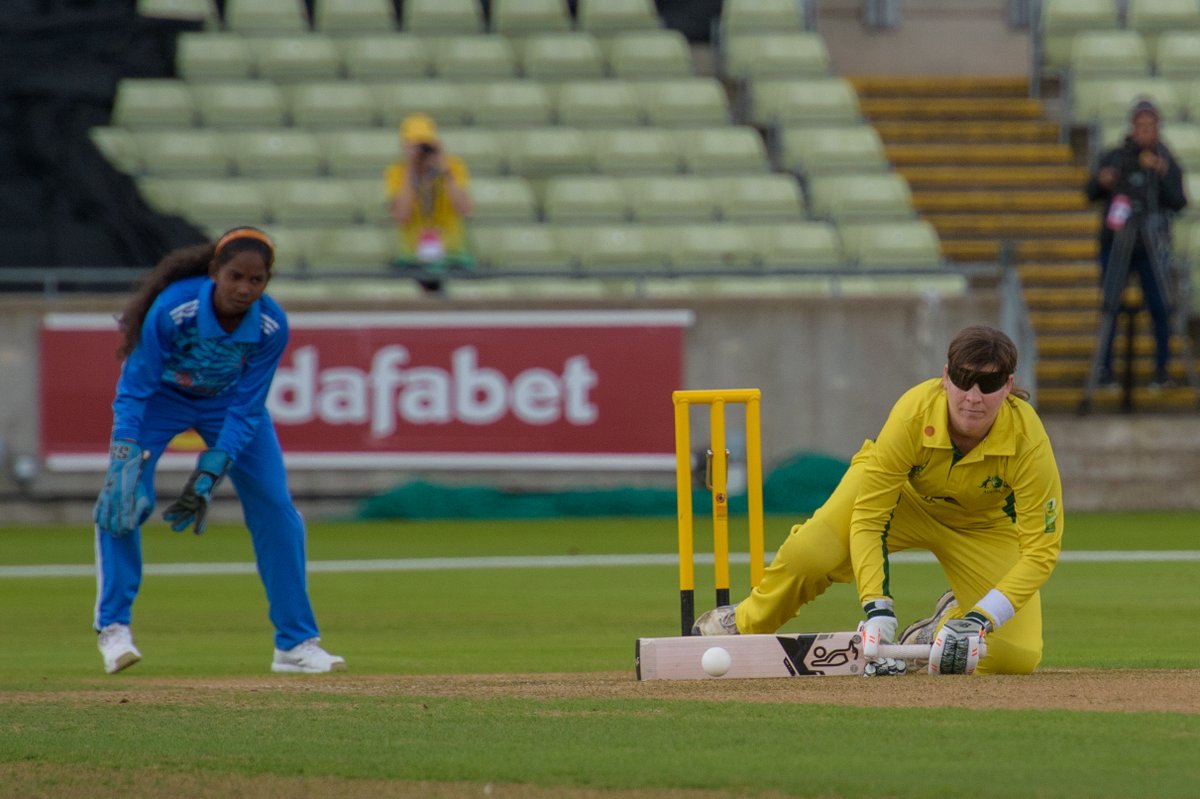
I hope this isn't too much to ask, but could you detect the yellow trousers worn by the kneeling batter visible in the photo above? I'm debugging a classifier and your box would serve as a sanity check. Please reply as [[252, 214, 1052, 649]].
[[737, 441, 1042, 674]]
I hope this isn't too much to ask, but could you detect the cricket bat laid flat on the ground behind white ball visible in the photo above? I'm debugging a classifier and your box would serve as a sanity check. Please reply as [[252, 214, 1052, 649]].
[[636, 632, 929, 680]]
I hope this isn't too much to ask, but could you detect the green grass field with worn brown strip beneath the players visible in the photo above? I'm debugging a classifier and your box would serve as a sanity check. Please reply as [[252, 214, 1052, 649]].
[[0, 513, 1200, 798]]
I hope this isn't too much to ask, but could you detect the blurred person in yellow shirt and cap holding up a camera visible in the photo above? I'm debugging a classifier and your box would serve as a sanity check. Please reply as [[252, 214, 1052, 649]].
[[384, 114, 474, 292]]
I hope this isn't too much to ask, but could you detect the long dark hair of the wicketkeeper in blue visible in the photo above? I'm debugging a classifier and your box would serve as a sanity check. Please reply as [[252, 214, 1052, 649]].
[[116, 227, 275, 358]]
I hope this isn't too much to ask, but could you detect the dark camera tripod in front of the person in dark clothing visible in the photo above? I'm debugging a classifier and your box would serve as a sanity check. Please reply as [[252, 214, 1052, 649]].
[[1079, 214, 1200, 414]]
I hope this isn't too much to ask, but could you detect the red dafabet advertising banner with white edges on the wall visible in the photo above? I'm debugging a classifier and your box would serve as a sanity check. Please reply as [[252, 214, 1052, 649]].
[[41, 311, 692, 470]]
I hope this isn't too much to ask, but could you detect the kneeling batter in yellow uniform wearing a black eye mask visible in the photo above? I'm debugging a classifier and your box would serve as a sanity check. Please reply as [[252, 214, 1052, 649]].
[[692, 325, 1063, 675]]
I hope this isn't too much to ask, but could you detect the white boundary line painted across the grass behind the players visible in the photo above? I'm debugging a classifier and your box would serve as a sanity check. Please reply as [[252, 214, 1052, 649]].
[[0, 549, 1200, 578]]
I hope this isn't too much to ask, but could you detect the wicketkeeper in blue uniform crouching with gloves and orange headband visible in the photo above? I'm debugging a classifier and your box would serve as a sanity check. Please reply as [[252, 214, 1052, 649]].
[[94, 228, 346, 674]]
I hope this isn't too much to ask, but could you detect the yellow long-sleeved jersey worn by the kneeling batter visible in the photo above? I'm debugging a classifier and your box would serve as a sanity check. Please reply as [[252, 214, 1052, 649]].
[[850, 378, 1063, 621]]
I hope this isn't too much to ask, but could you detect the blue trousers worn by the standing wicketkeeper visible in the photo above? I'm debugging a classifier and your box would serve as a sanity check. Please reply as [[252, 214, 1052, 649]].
[[94, 394, 318, 649]]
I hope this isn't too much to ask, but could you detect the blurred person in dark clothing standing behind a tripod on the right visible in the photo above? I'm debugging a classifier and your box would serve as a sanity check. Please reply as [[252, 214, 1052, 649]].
[[1085, 100, 1188, 388]]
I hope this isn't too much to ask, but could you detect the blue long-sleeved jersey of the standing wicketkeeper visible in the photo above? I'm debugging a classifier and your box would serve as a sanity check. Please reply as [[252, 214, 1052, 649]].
[[113, 277, 288, 459]]
